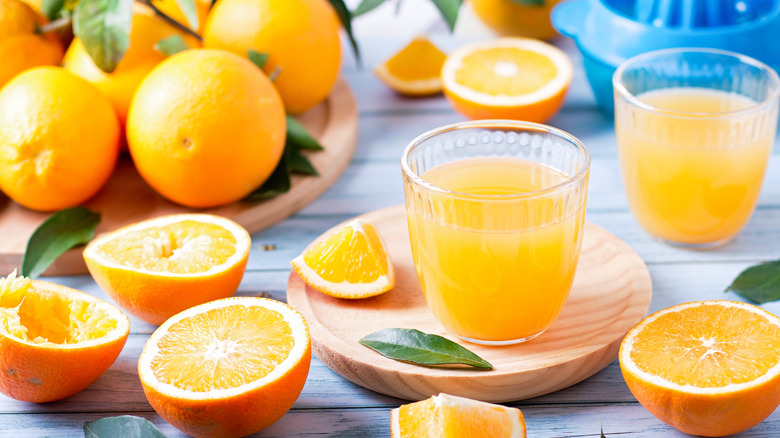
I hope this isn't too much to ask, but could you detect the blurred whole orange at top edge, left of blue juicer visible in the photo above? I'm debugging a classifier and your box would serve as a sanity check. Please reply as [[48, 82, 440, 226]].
[[471, 0, 561, 40]]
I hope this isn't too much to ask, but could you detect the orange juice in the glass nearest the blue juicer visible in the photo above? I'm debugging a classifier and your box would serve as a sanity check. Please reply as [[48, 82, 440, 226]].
[[615, 88, 774, 245]]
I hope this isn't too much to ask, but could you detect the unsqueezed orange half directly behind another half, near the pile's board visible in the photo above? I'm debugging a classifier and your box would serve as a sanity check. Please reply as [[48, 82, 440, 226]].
[[84, 214, 251, 324]]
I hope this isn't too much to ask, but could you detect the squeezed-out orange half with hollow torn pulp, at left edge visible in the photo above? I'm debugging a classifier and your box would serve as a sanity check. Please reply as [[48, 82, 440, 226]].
[[0, 272, 130, 403]]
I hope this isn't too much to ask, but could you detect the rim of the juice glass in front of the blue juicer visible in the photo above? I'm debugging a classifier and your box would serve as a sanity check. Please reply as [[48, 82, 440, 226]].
[[612, 47, 780, 120]]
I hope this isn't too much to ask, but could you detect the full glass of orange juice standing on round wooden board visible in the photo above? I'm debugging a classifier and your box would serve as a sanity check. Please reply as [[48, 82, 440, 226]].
[[401, 120, 590, 345]]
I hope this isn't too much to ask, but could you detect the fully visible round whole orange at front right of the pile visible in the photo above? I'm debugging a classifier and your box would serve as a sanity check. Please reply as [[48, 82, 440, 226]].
[[127, 49, 286, 207]]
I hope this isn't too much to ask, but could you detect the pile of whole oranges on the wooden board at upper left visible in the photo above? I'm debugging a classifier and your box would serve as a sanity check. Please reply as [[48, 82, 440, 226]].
[[0, 0, 341, 211]]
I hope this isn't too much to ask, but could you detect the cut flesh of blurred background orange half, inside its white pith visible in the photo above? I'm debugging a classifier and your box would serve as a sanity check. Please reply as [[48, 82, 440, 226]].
[[455, 47, 558, 96]]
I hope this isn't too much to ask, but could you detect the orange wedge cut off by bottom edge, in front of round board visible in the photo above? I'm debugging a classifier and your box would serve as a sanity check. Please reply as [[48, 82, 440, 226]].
[[390, 394, 525, 438]]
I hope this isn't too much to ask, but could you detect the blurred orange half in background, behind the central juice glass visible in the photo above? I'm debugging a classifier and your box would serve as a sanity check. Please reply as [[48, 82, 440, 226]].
[[441, 38, 574, 122]]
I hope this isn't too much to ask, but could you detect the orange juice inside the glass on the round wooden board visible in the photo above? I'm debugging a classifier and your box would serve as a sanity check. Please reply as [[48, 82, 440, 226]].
[[407, 157, 587, 343]]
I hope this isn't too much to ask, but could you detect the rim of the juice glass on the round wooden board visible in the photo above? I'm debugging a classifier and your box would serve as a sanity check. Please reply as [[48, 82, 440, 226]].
[[401, 119, 591, 201]]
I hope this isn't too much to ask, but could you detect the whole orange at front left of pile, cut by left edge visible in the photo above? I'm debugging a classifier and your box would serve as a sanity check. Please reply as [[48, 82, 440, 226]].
[[0, 67, 119, 211]]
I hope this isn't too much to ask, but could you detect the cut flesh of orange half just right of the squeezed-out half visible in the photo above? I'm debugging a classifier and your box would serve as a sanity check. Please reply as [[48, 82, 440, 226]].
[[151, 305, 295, 392]]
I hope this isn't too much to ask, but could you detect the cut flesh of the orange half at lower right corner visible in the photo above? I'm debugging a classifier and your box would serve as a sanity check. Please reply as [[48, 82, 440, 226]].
[[631, 306, 780, 388]]
